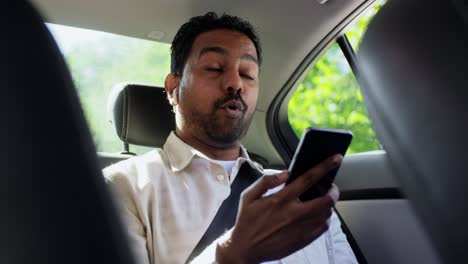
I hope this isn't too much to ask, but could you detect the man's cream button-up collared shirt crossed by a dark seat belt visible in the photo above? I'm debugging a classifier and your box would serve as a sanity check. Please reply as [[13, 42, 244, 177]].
[[103, 133, 357, 264]]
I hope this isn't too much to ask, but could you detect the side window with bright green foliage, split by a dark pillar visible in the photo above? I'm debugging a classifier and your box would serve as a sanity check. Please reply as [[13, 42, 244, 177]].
[[288, 1, 384, 154]]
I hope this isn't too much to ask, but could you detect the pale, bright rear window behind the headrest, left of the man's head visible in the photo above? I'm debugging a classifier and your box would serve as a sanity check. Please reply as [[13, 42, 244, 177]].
[[47, 24, 170, 154]]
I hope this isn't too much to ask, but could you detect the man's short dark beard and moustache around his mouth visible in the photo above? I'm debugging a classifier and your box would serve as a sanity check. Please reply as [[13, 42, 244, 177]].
[[181, 93, 253, 147]]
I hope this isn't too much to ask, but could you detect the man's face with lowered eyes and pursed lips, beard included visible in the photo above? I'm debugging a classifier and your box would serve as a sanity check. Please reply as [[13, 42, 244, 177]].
[[177, 30, 259, 148]]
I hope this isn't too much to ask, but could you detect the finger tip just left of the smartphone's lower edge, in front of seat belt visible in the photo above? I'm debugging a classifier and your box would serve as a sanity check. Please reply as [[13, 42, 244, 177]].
[[242, 171, 288, 201]]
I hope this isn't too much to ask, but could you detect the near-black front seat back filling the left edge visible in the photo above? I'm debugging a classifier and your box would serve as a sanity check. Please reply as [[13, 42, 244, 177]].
[[0, 0, 134, 264]]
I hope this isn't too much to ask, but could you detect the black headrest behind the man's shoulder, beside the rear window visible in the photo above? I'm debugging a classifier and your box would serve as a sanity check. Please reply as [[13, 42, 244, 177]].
[[108, 83, 175, 148]]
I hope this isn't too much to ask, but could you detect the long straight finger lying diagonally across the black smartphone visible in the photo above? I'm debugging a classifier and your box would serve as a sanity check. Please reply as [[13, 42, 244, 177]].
[[279, 154, 343, 200]]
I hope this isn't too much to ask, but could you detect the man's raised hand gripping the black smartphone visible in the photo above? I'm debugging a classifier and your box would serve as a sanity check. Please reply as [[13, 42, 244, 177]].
[[216, 154, 343, 264]]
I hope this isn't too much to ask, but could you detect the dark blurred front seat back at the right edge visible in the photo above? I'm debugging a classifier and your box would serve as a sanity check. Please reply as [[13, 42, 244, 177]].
[[357, 0, 468, 263]]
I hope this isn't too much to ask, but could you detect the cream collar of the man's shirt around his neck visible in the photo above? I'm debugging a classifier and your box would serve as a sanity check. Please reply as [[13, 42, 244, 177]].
[[163, 131, 252, 172]]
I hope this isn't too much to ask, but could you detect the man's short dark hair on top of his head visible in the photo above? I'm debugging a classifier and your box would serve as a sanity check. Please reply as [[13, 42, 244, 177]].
[[171, 12, 262, 76]]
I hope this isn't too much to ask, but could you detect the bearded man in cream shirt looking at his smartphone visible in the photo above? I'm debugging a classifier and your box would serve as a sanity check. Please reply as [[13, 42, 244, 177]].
[[104, 13, 356, 264]]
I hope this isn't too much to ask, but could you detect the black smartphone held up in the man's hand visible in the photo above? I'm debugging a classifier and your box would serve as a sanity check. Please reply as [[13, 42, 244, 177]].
[[286, 127, 353, 201]]
